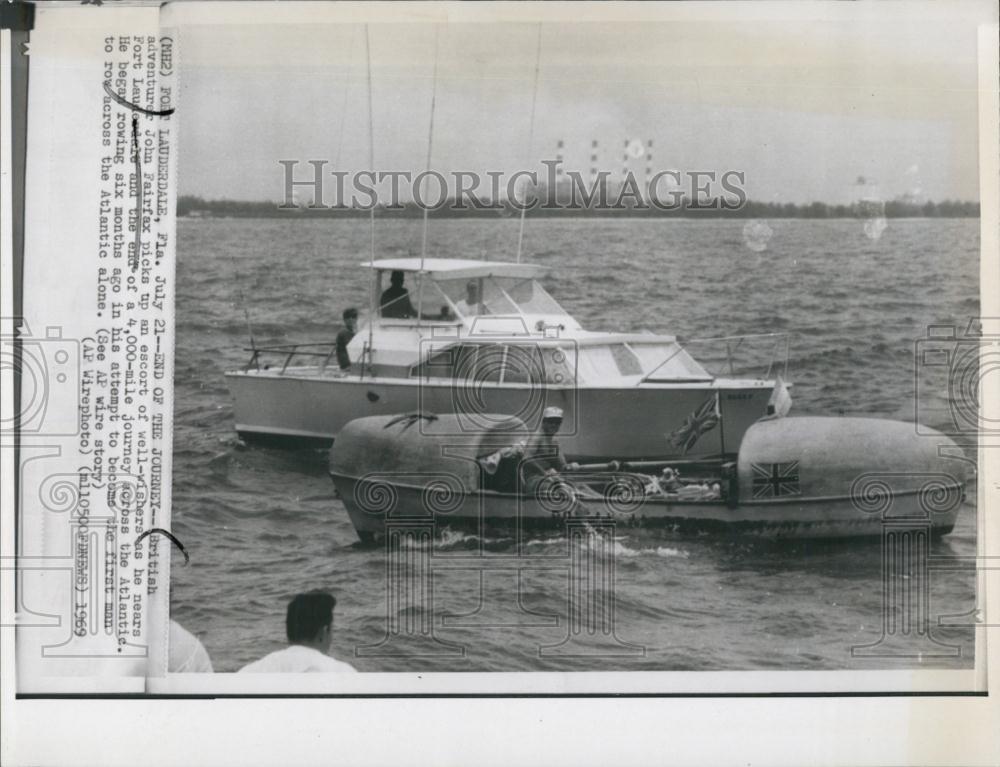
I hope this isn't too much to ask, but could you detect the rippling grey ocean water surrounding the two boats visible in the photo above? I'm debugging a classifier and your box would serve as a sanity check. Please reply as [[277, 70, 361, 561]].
[[171, 218, 979, 671]]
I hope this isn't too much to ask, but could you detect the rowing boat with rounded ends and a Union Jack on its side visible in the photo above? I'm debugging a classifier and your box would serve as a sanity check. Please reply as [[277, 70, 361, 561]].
[[330, 414, 973, 542]]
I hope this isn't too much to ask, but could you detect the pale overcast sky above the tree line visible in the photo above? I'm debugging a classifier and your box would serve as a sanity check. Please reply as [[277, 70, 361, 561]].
[[178, 2, 996, 202]]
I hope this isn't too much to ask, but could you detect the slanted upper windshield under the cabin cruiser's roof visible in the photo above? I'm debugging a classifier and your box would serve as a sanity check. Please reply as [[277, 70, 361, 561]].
[[436, 276, 569, 317]]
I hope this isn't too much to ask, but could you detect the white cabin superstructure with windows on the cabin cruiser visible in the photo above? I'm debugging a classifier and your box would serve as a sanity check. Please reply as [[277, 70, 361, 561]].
[[348, 258, 712, 386]]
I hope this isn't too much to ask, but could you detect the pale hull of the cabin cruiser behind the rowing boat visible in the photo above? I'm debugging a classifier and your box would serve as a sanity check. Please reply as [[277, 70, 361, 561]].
[[226, 371, 773, 461]]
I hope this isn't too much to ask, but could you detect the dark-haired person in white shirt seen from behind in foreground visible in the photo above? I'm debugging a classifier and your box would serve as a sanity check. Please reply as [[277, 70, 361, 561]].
[[239, 591, 355, 674]]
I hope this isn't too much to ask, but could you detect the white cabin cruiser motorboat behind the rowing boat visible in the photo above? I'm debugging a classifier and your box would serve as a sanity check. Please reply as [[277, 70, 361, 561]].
[[226, 258, 790, 461]]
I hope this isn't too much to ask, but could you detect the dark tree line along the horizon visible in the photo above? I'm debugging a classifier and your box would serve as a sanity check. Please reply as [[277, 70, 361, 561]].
[[177, 195, 979, 218]]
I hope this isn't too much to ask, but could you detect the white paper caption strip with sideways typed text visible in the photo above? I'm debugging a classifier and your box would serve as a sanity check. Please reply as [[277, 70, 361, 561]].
[[17, 8, 177, 691]]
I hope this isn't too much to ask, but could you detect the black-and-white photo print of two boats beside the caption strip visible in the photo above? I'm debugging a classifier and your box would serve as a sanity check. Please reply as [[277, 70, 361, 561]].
[[164, 4, 980, 689]]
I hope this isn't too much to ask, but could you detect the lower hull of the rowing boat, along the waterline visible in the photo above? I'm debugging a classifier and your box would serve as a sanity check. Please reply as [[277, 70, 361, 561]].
[[331, 473, 964, 541]]
